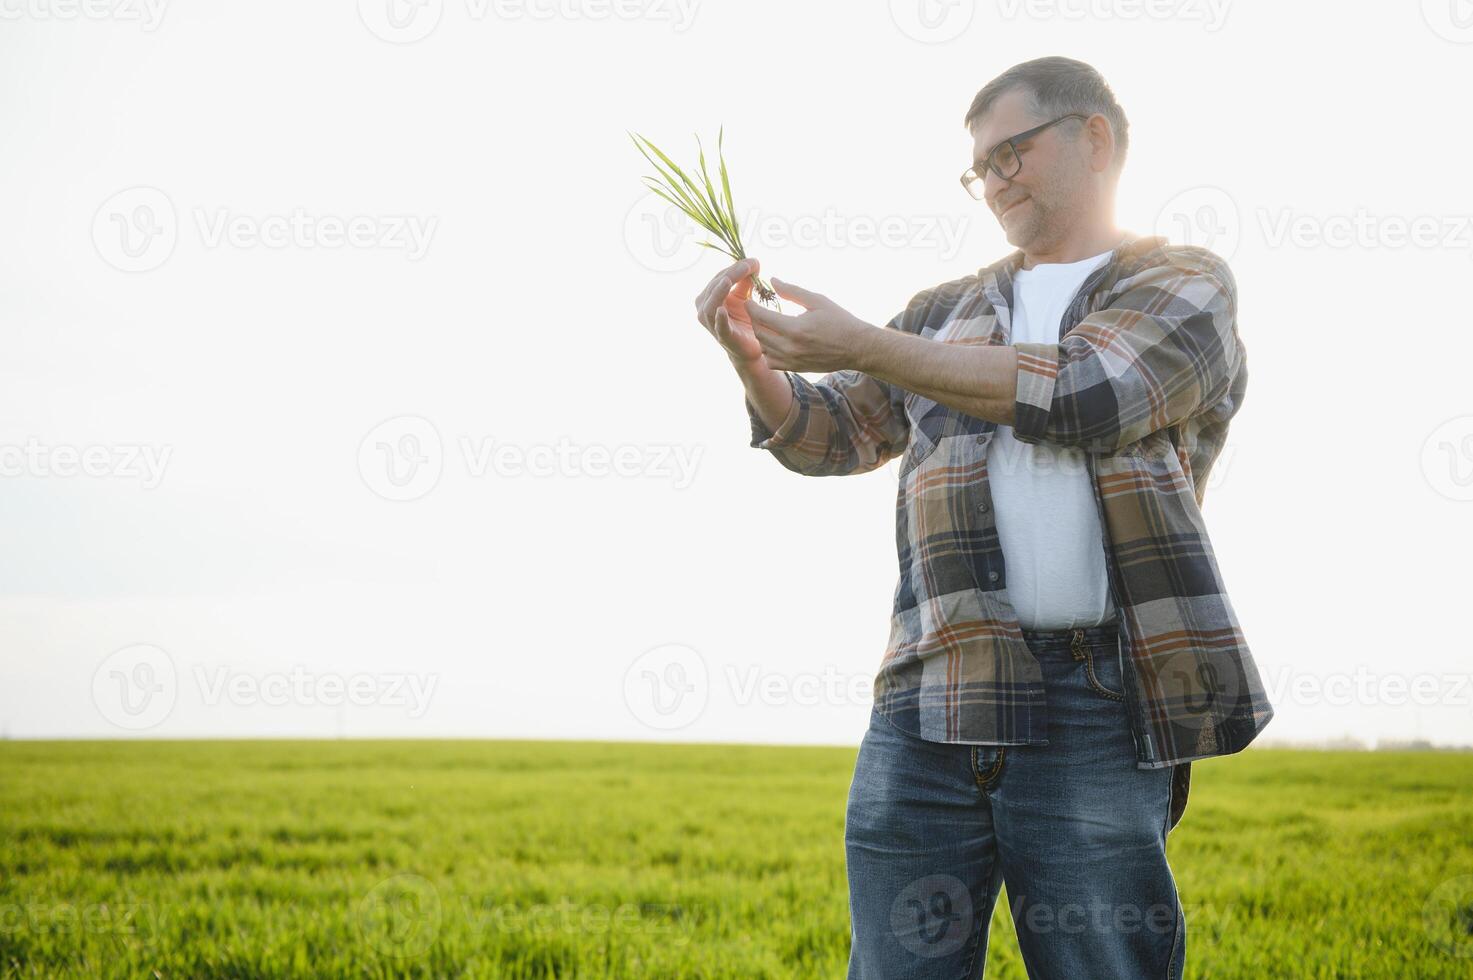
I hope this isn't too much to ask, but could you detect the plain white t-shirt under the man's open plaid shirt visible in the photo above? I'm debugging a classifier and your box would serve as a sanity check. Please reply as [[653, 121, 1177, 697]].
[[987, 252, 1117, 629]]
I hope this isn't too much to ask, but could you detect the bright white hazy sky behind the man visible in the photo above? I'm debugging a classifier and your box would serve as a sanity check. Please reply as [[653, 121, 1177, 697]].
[[0, 0, 1473, 744]]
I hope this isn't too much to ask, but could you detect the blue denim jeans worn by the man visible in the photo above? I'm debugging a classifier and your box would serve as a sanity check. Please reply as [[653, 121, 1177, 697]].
[[844, 623, 1186, 980]]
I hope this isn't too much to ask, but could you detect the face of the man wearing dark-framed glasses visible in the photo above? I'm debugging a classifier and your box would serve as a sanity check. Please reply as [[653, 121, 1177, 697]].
[[972, 90, 1093, 251]]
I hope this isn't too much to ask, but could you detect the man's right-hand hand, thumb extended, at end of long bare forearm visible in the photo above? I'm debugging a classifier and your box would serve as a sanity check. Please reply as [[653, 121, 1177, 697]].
[[745, 277, 875, 374]]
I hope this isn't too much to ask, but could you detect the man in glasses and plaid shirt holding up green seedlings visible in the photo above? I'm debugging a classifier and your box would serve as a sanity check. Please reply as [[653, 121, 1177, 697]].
[[697, 57, 1273, 980]]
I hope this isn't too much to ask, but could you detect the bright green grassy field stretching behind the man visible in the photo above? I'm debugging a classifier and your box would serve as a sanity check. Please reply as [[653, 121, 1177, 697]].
[[0, 741, 1473, 980]]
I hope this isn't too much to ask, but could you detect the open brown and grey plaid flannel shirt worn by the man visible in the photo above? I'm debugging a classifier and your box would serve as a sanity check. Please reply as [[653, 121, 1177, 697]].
[[747, 233, 1274, 827]]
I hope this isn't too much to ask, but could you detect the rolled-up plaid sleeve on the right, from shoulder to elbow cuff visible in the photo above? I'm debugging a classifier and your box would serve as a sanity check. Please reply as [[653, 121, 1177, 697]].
[[1013, 246, 1246, 452]]
